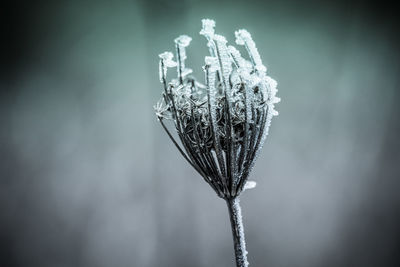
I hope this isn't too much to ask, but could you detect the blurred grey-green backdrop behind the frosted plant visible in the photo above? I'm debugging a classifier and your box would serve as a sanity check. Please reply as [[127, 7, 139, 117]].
[[0, 0, 400, 267]]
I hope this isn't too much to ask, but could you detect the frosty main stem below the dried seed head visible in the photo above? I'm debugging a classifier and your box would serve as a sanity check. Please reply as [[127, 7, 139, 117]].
[[226, 197, 249, 267]]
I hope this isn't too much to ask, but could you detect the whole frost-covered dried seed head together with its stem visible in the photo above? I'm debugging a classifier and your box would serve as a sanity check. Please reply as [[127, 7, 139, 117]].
[[155, 19, 280, 267]]
